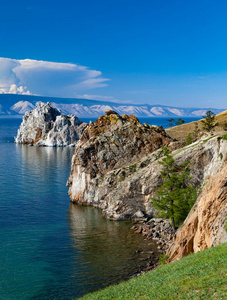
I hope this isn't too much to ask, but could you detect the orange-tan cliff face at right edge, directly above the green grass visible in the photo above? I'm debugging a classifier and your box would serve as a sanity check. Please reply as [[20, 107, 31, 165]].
[[167, 164, 227, 261]]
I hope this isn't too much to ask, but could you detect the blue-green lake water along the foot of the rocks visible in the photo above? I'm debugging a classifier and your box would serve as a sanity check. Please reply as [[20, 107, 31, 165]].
[[0, 119, 160, 300]]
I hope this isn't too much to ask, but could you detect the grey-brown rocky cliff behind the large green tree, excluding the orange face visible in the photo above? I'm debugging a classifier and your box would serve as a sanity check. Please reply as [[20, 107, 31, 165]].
[[67, 112, 227, 220]]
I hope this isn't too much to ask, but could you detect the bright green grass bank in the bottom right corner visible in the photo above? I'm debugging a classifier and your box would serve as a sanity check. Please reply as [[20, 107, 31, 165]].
[[80, 243, 227, 300]]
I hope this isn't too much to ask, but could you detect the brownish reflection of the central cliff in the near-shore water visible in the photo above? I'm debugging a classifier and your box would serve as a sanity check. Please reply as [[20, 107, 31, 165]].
[[68, 204, 156, 288]]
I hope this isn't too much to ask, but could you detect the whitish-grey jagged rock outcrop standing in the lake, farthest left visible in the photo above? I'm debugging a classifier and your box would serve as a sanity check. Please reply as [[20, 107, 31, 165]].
[[15, 102, 87, 147]]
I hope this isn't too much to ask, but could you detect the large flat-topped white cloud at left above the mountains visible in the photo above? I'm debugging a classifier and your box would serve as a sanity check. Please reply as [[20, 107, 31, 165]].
[[0, 57, 109, 97]]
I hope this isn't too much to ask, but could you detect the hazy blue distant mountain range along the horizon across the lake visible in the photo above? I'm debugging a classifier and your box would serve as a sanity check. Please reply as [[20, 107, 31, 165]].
[[0, 94, 225, 118]]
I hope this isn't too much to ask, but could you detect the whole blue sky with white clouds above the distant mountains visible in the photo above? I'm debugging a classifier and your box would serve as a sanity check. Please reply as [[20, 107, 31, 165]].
[[0, 0, 227, 108]]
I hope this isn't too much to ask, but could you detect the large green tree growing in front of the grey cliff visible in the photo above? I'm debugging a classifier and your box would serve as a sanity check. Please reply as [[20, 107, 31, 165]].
[[152, 147, 197, 231]]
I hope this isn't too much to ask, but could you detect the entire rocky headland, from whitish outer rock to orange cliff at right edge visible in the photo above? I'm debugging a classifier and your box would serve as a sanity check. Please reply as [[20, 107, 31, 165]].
[[16, 103, 227, 269]]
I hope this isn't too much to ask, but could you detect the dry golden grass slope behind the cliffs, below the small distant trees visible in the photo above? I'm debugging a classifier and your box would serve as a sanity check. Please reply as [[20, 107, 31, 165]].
[[166, 110, 227, 140]]
